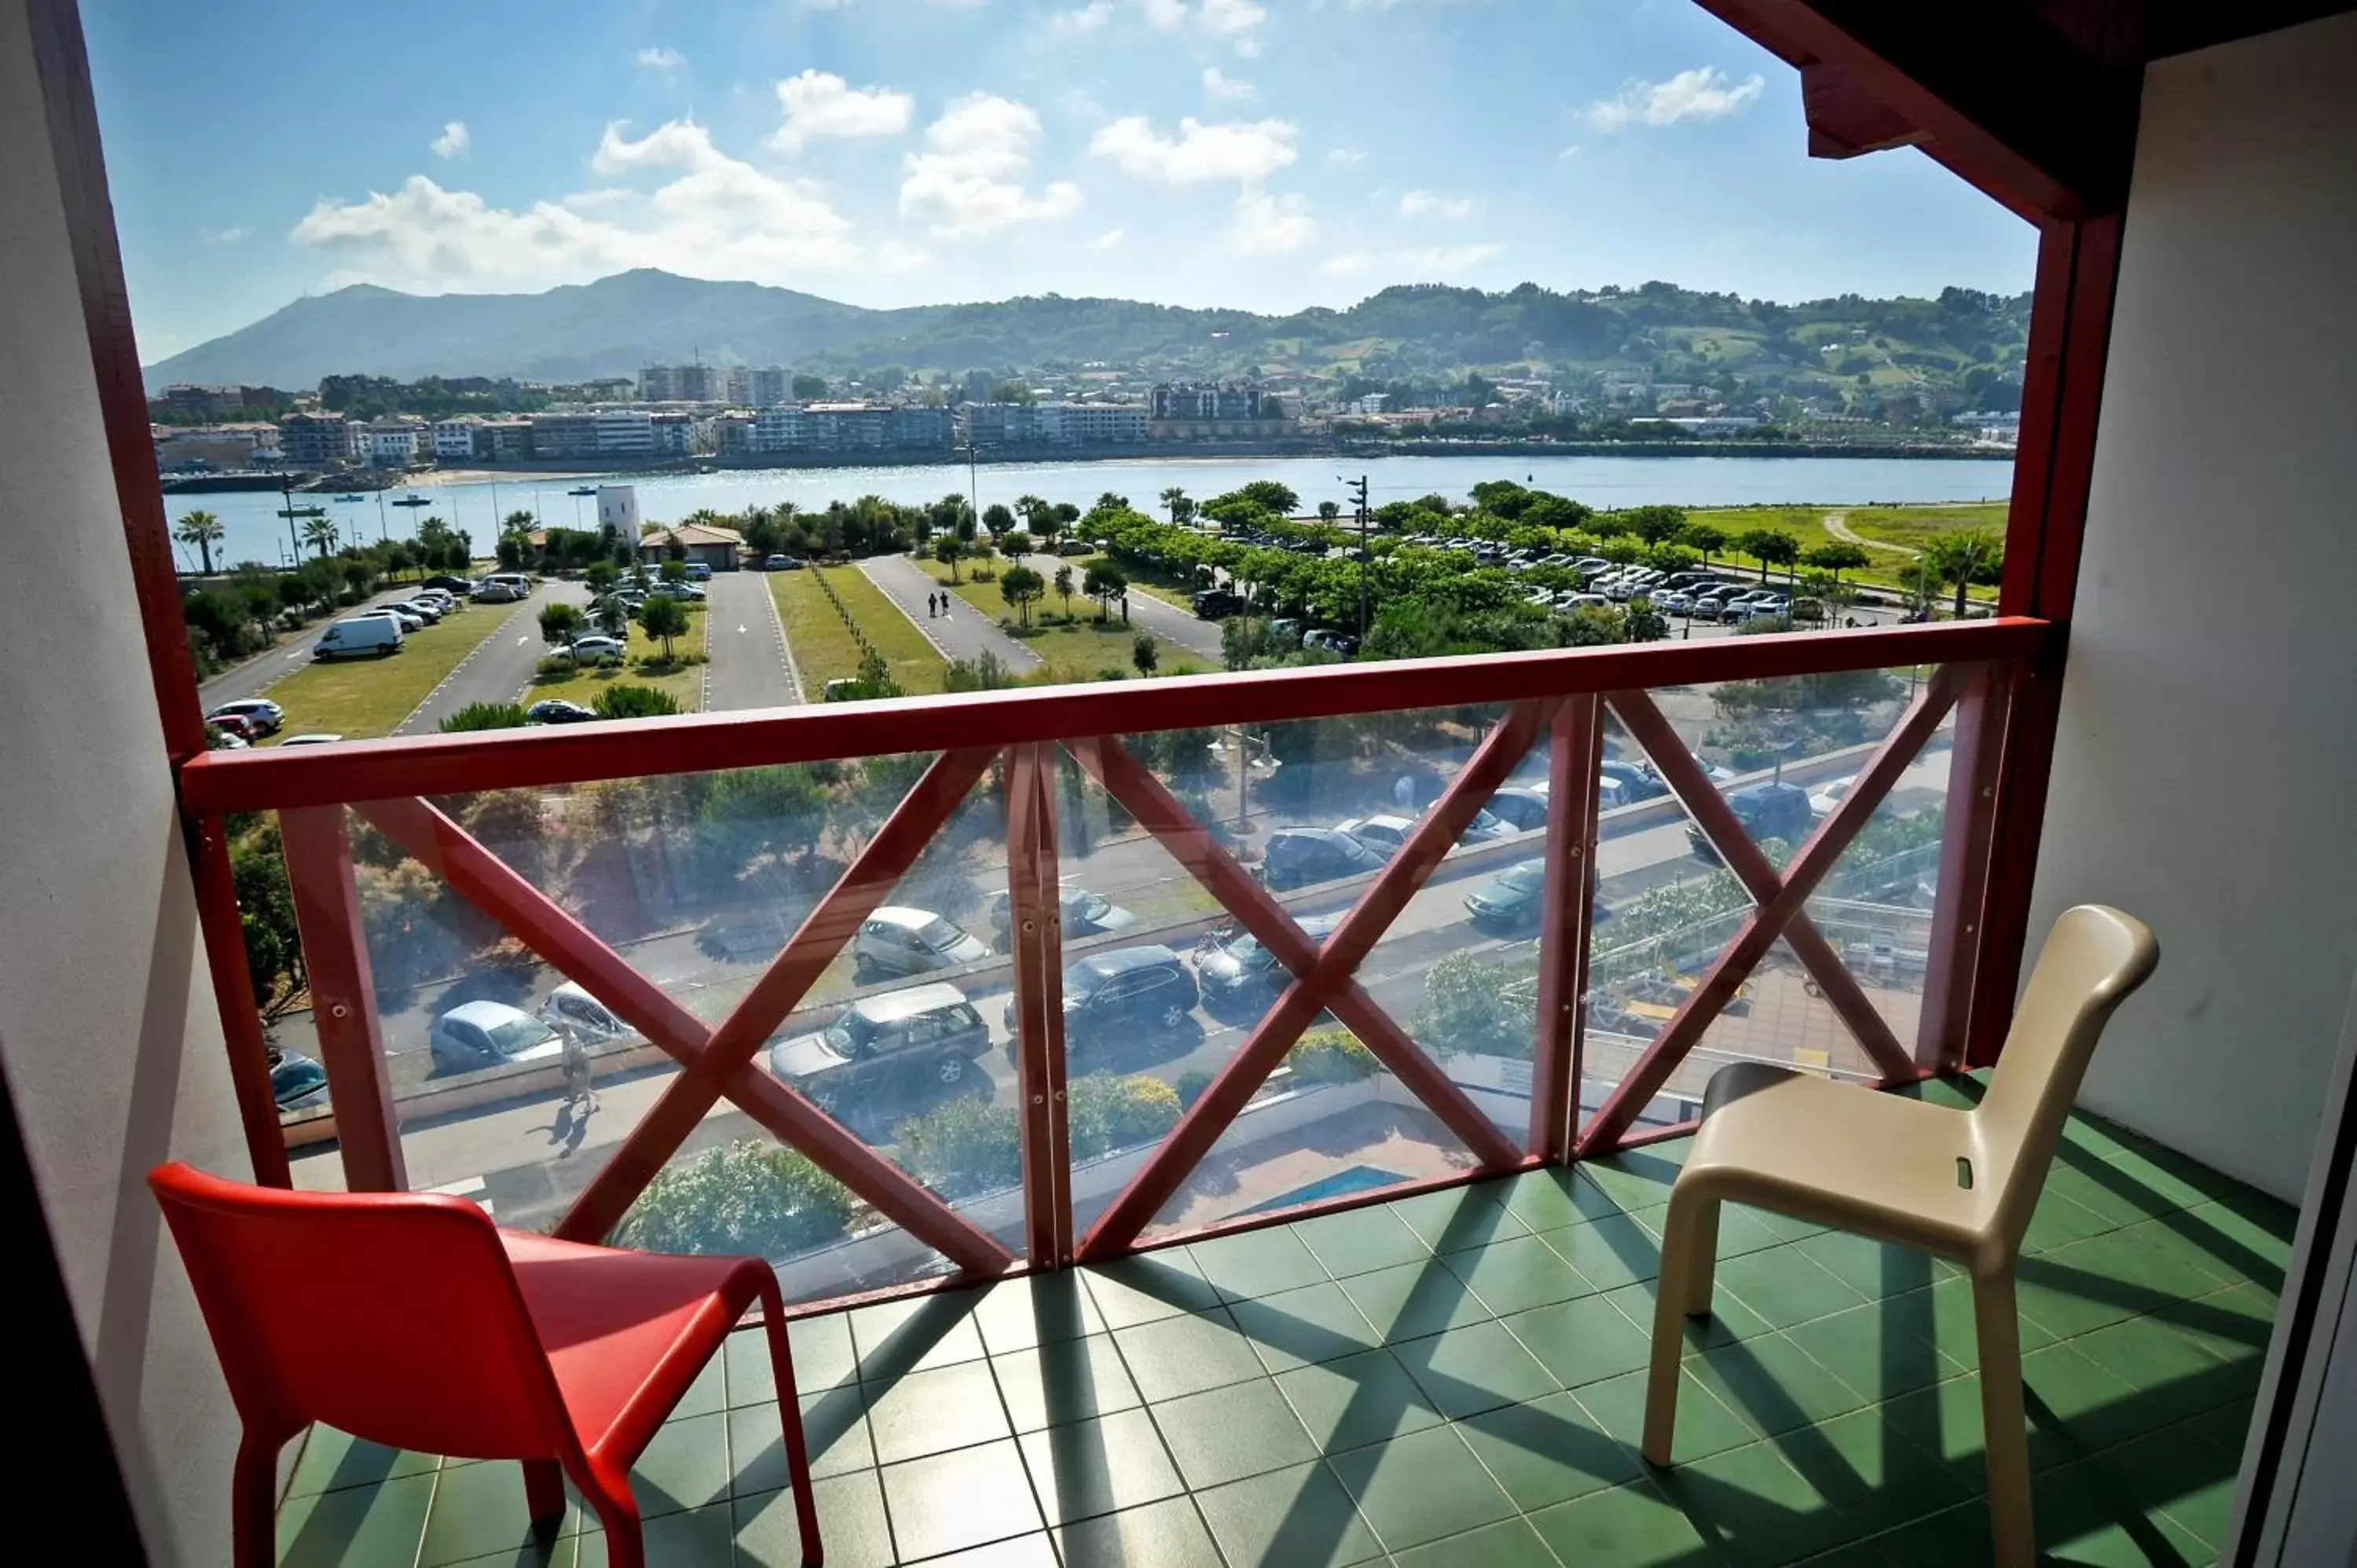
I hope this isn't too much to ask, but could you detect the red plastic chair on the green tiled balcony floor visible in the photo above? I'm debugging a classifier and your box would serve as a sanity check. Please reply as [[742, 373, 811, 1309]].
[[148, 1163, 820, 1568]]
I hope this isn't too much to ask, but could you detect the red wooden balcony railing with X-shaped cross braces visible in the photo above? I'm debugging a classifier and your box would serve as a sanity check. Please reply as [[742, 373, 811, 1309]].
[[181, 617, 2053, 1276]]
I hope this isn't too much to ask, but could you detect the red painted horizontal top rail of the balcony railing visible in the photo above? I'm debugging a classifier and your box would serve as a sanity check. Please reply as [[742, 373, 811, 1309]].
[[181, 620, 2046, 814]]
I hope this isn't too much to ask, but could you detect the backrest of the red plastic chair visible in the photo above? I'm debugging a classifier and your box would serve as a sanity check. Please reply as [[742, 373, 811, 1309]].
[[148, 1163, 573, 1460]]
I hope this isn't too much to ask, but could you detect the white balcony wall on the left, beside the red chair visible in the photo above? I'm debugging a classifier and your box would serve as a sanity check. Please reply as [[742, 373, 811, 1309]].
[[0, 0, 250, 1563]]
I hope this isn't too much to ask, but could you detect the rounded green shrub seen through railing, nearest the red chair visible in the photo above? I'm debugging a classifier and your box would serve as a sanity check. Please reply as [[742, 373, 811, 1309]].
[[615, 1139, 851, 1257]]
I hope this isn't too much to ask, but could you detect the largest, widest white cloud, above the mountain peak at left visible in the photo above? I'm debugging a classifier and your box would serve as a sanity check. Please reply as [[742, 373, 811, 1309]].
[[290, 120, 863, 292]]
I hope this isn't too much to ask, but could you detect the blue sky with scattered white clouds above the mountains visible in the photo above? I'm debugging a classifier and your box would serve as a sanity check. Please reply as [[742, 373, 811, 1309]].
[[85, 0, 2034, 358]]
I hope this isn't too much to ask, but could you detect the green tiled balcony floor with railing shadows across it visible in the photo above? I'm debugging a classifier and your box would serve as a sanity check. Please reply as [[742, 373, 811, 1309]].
[[280, 1090, 2293, 1568]]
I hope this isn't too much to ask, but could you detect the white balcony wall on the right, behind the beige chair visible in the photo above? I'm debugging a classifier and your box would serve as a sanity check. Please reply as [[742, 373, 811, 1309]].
[[2032, 16, 2357, 1198]]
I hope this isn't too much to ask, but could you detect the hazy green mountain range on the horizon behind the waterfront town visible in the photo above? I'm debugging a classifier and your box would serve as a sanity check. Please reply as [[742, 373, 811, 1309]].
[[146, 271, 2027, 391]]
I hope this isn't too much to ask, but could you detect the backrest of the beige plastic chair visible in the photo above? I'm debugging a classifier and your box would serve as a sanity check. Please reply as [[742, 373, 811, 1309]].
[[1973, 903, 2161, 1245]]
